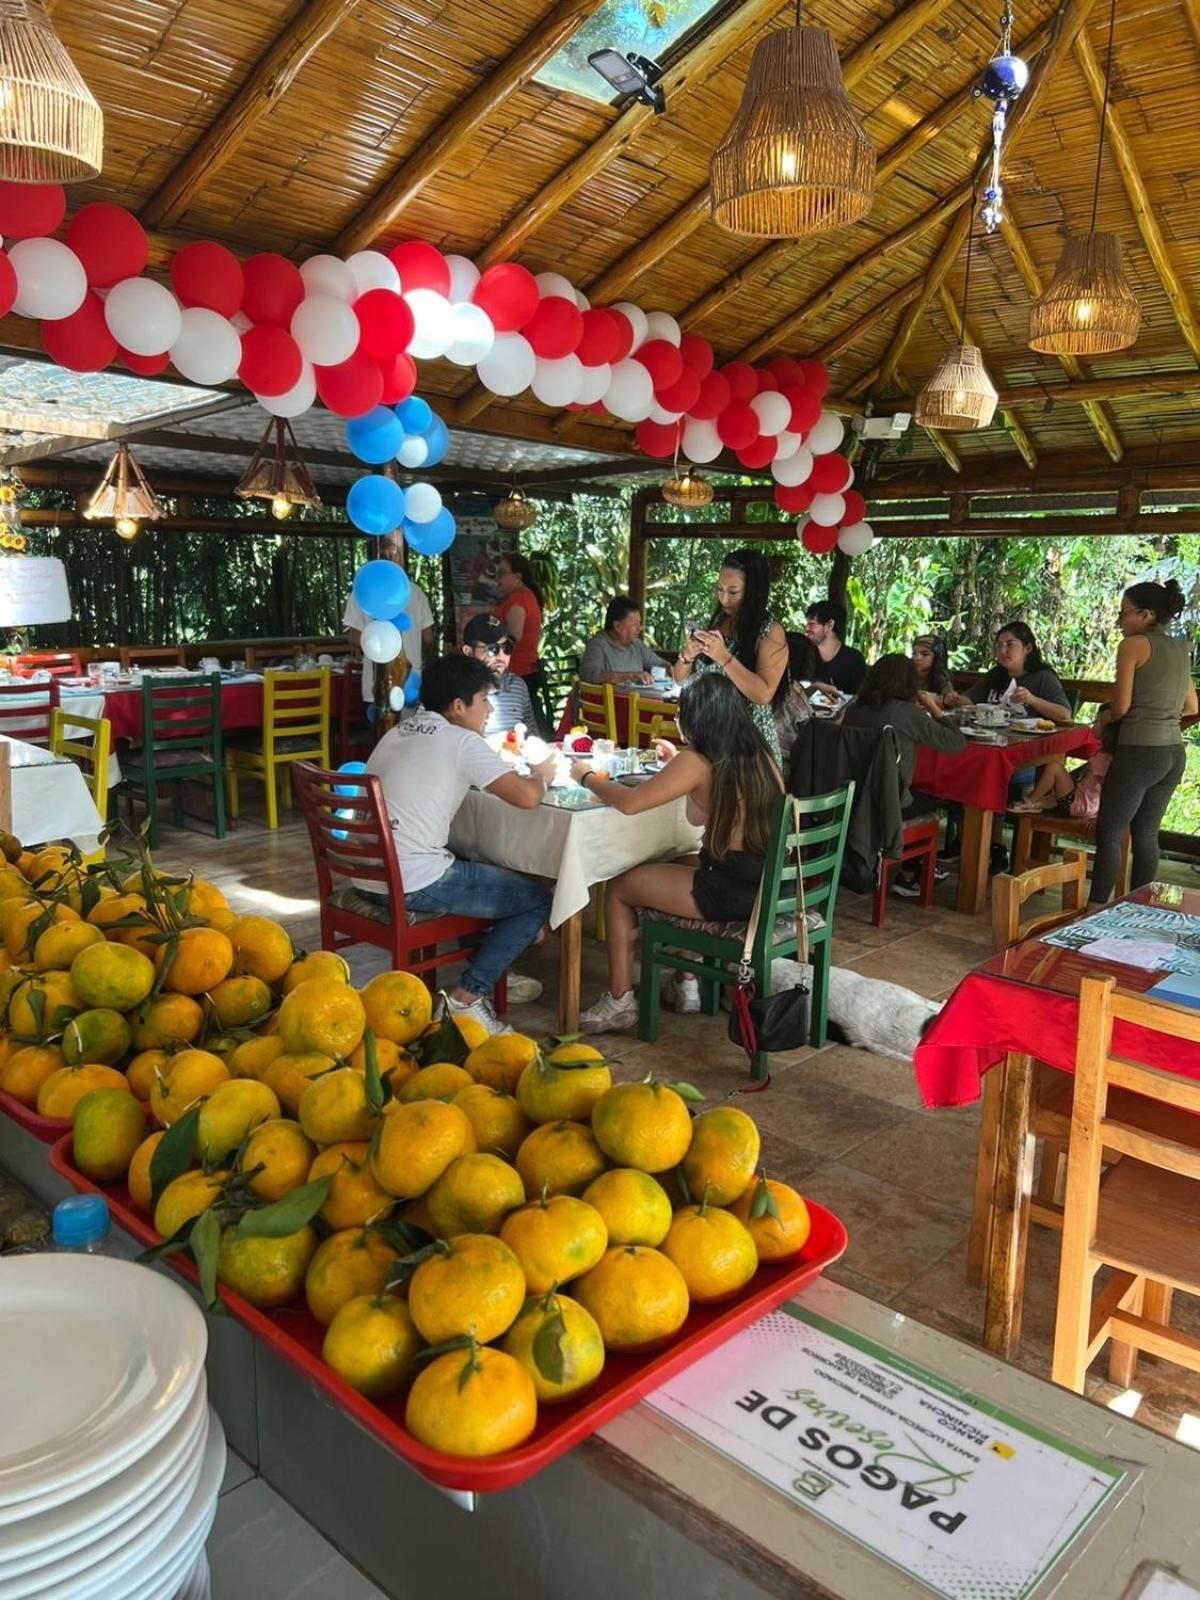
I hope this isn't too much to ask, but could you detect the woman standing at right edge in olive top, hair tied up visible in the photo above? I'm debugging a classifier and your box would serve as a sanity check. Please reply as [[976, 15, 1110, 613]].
[[1088, 579, 1197, 906]]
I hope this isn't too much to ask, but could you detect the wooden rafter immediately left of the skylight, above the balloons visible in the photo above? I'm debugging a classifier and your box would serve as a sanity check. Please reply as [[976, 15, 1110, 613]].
[[333, 0, 603, 256]]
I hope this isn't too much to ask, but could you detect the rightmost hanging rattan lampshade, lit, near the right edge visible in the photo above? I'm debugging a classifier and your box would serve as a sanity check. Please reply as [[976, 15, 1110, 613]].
[[1029, 234, 1142, 355]]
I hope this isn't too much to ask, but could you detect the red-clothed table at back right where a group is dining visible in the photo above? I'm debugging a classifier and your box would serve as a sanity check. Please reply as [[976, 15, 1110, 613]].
[[912, 723, 1098, 914]]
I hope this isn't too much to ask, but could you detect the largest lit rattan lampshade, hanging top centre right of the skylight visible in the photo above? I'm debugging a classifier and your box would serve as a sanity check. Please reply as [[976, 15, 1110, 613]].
[[710, 26, 875, 238]]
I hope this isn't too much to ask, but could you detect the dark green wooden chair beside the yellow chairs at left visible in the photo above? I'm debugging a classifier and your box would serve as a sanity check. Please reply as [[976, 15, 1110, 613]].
[[123, 672, 226, 850]]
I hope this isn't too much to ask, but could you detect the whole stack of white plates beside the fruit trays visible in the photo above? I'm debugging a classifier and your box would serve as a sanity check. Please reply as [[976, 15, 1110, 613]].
[[0, 1254, 226, 1600]]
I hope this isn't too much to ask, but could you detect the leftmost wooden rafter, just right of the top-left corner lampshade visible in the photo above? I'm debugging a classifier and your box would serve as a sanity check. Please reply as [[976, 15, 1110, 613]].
[[142, 0, 360, 227]]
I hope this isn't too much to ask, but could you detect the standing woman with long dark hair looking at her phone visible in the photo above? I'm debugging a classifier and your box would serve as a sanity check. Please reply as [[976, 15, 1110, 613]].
[[672, 550, 787, 762]]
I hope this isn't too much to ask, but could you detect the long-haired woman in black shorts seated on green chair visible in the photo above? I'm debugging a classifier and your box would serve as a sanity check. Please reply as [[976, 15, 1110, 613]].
[[571, 672, 782, 1034]]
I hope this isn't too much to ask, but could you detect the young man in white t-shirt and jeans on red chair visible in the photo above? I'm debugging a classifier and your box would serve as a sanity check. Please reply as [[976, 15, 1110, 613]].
[[366, 654, 554, 1034]]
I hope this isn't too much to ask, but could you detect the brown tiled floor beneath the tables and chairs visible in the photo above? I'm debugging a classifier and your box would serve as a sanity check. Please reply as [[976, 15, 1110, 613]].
[[148, 811, 1200, 1445]]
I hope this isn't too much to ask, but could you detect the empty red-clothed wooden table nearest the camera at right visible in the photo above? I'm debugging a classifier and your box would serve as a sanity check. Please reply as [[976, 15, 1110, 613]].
[[912, 883, 1200, 1360]]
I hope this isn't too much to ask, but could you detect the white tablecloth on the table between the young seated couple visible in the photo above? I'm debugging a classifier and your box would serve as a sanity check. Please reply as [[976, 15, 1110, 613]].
[[450, 790, 701, 928]]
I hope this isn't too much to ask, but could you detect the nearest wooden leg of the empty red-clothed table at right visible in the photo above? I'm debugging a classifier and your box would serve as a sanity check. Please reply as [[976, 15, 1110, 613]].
[[984, 1054, 1034, 1360]]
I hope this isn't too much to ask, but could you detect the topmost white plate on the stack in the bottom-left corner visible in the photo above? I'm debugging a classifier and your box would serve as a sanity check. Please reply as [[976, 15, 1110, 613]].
[[0, 1254, 208, 1520]]
